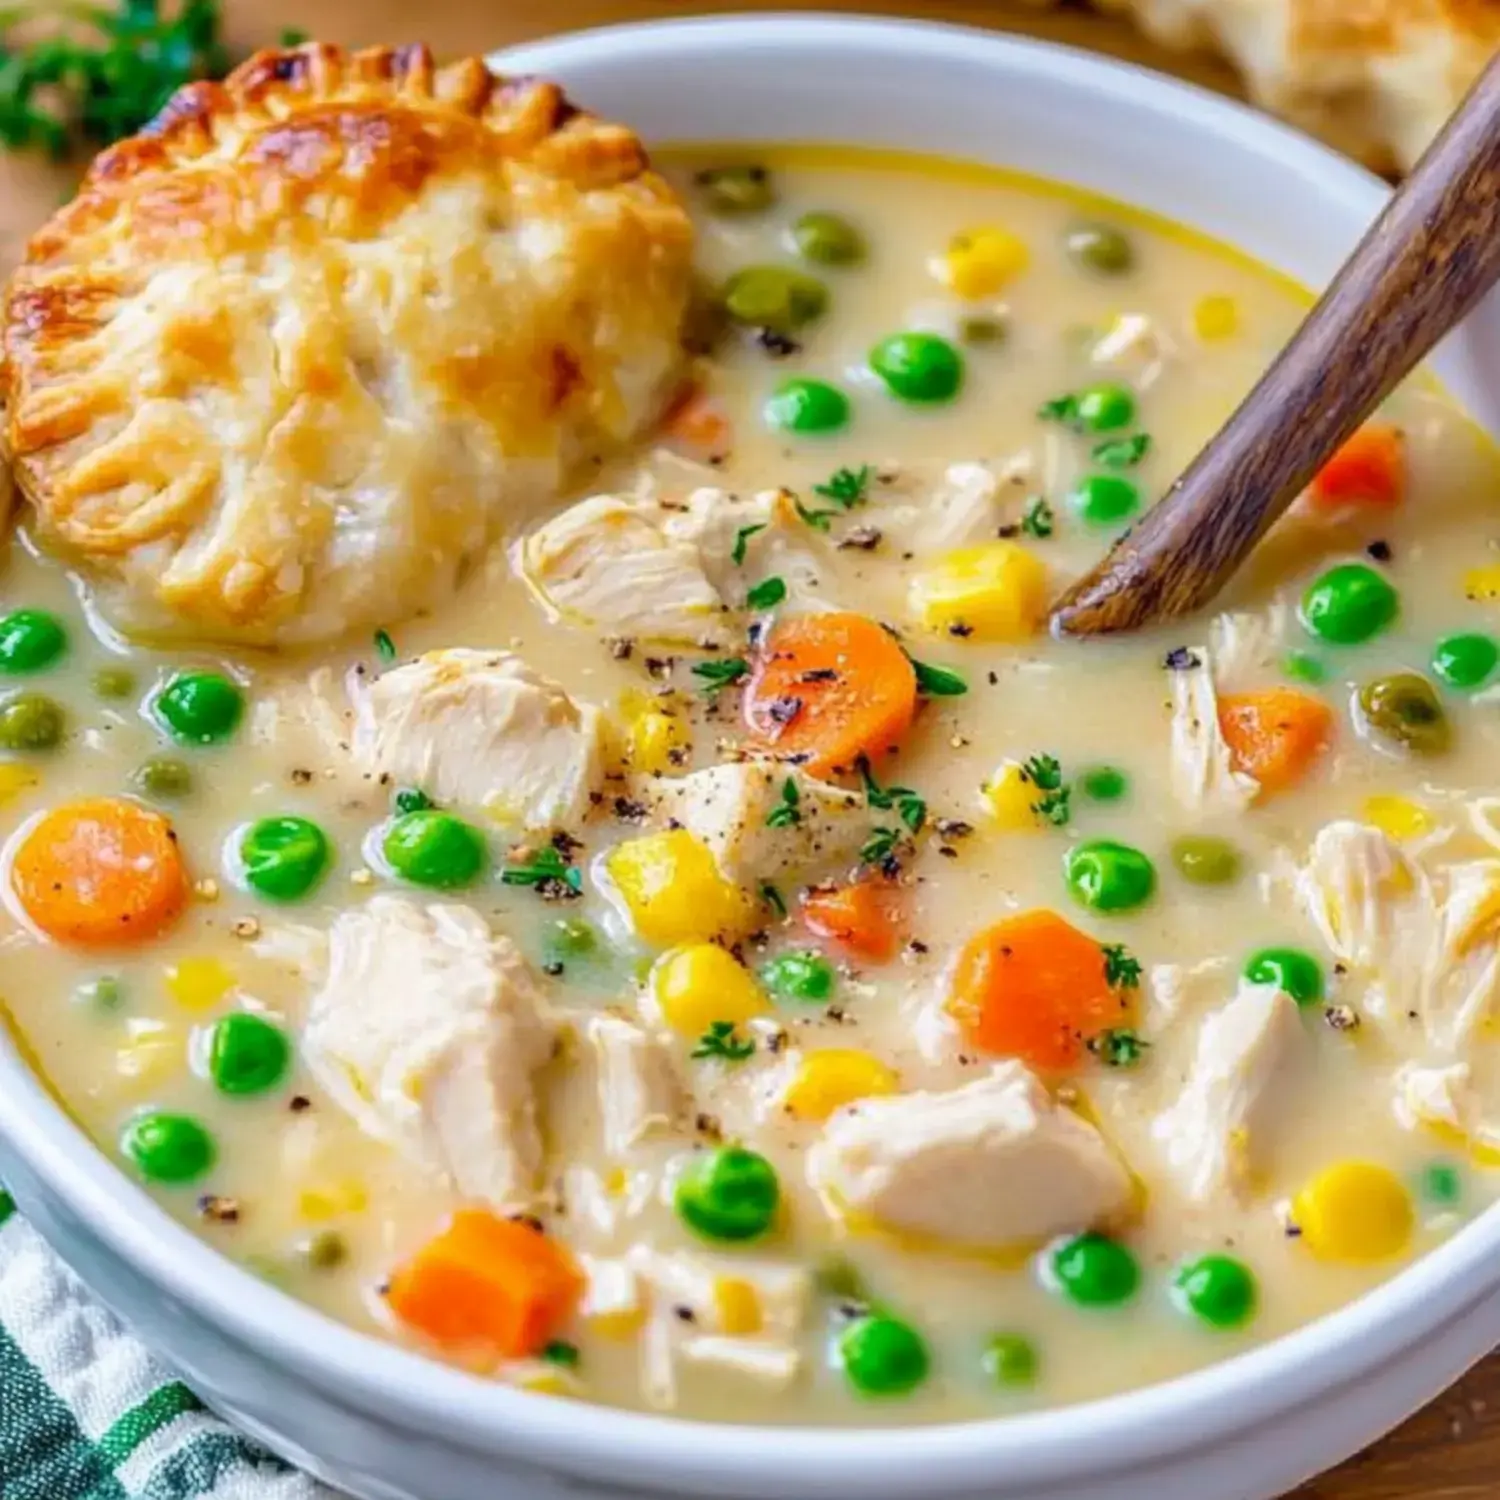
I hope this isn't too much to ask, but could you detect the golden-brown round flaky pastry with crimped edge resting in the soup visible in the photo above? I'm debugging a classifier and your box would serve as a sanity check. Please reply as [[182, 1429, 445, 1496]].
[[3, 44, 693, 645]]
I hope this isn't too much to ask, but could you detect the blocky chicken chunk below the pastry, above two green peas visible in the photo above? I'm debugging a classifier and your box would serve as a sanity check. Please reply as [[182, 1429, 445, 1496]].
[[354, 650, 605, 831]]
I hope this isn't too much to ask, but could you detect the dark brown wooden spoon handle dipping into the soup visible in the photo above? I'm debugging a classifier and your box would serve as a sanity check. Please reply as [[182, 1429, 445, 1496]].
[[1052, 59, 1500, 636]]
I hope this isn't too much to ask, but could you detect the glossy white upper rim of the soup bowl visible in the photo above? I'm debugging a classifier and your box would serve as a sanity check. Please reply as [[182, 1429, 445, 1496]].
[[0, 12, 1500, 1494]]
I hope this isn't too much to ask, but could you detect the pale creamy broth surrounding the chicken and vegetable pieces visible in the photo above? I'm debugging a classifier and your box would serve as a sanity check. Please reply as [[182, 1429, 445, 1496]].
[[0, 149, 1500, 1424]]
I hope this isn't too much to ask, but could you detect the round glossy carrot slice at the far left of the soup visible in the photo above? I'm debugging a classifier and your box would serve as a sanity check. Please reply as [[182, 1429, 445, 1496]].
[[11, 797, 188, 948]]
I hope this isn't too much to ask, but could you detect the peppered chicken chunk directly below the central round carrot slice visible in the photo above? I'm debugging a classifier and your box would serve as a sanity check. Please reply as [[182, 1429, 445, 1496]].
[[641, 761, 875, 888]]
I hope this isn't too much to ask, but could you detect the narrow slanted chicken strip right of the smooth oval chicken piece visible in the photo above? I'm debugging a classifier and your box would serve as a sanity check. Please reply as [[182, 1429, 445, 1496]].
[[1152, 984, 1305, 1203]]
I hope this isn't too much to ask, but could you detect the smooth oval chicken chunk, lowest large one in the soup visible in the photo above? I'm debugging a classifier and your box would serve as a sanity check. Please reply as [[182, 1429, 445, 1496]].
[[807, 1062, 1134, 1248]]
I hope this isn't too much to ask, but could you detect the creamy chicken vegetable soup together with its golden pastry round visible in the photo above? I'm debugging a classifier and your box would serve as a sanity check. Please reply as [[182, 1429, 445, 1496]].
[[0, 50, 1500, 1424]]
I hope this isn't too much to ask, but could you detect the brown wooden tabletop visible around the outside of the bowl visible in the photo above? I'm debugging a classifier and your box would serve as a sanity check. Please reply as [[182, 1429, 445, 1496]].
[[11, 0, 1500, 1500]]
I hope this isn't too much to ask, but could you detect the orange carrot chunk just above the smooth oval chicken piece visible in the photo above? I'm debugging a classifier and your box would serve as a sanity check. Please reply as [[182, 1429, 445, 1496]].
[[948, 908, 1131, 1073]]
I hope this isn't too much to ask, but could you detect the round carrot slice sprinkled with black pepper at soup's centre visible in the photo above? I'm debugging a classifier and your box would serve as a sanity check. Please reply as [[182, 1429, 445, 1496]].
[[744, 614, 917, 776]]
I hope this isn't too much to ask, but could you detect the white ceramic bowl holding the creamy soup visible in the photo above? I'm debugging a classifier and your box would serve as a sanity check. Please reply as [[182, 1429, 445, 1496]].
[[0, 17, 1500, 1500]]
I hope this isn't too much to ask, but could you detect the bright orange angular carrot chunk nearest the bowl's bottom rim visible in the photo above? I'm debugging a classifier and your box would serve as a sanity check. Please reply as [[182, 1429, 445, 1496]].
[[387, 1209, 584, 1359]]
